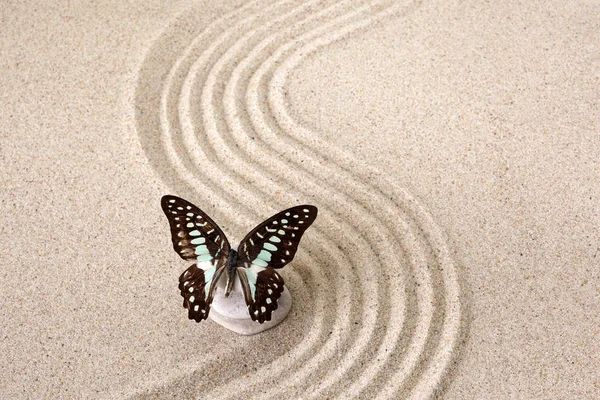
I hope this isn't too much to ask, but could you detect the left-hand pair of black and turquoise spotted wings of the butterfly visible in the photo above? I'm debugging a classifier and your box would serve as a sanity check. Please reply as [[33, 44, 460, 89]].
[[161, 196, 230, 322]]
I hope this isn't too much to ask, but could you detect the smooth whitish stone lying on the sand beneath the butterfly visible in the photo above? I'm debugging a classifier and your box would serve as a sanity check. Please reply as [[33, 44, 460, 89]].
[[208, 273, 292, 335]]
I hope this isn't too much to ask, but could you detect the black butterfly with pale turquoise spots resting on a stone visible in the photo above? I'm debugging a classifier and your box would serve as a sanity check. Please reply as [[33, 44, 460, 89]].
[[161, 195, 317, 324]]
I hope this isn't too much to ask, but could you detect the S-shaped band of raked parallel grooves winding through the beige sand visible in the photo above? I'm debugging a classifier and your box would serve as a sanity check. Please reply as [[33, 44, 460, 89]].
[[136, 1, 460, 398]]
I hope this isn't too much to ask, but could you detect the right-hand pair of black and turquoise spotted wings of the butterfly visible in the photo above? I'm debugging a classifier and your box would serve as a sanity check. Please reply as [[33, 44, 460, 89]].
[[238, 205, 317, 324]]
